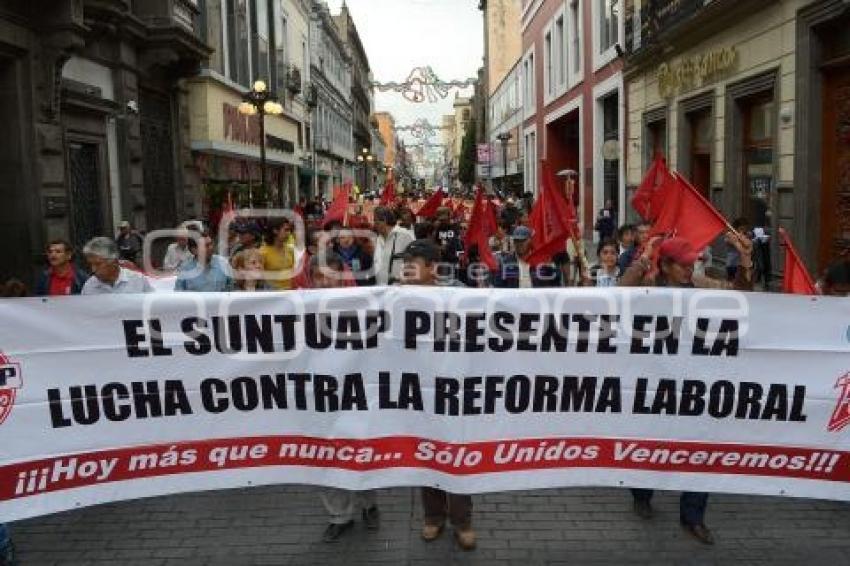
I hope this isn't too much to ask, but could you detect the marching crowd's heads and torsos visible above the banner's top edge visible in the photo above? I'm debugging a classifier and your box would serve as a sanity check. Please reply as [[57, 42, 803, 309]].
[[0, 195, 846, 297]]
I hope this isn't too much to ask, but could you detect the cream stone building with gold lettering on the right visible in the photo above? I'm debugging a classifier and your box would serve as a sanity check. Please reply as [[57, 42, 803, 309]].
[[625, 0, 850, 271]]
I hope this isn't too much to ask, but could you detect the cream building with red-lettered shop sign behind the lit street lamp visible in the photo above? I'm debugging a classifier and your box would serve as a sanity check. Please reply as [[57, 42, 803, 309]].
[[186, 0, 312, 207]]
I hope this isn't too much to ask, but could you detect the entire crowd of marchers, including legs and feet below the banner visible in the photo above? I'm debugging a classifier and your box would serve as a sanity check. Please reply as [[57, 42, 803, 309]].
[[0, 189, 850, 563]]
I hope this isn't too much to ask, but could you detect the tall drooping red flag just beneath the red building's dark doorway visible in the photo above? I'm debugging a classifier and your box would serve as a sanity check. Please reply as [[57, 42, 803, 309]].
[[526, 161, 581, 267]]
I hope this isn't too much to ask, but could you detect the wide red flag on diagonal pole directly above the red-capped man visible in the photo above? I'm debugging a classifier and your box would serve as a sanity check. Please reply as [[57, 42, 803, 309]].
[[651, 174, 729, 250]]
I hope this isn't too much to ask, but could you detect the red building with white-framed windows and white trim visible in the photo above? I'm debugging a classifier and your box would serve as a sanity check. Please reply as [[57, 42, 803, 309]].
[[520, 0, 627, 237]]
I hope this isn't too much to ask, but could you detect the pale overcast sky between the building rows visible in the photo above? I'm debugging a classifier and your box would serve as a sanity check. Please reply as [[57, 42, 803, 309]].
[[327, 0, 484, 156]]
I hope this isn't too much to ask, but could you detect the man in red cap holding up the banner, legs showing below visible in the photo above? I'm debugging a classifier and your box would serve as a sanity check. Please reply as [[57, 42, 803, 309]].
[[620, 231, 753, 544]]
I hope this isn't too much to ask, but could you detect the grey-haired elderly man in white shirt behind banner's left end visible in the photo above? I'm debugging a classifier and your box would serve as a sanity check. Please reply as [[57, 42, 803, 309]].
[[82, 237, 153, 295]]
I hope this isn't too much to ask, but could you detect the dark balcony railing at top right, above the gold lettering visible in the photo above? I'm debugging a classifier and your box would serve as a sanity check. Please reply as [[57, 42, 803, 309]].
[[626, 0, 714, 54]]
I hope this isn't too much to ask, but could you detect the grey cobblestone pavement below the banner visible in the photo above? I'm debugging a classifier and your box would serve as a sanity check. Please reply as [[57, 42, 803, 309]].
[[12, 486, 850, 566]]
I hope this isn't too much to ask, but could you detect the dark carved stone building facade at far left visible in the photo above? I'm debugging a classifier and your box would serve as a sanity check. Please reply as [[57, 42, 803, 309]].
[[0, 0, 210, 283]]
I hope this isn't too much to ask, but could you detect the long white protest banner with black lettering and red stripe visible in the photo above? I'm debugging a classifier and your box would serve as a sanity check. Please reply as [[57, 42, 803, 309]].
[[0, 287, 850, 520]]
